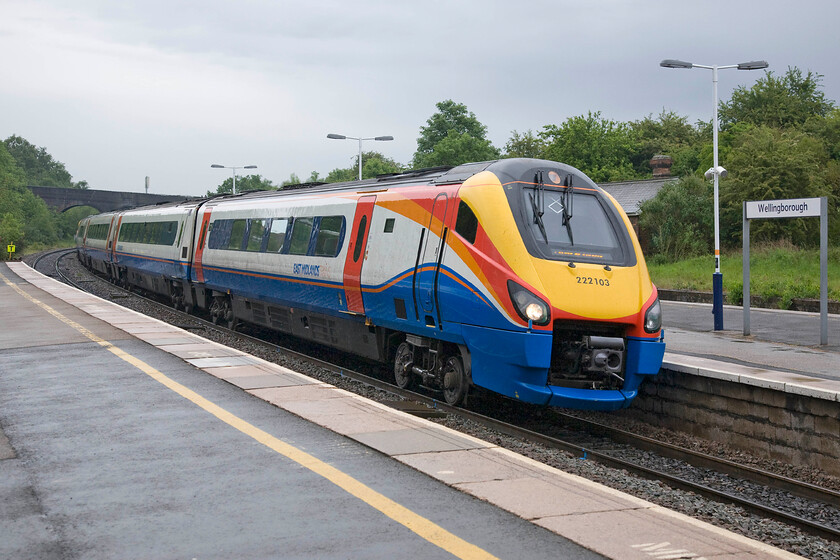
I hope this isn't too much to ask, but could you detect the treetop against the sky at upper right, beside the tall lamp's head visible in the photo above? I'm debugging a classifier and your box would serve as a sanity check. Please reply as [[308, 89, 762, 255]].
[[719, 67, 834, 128]]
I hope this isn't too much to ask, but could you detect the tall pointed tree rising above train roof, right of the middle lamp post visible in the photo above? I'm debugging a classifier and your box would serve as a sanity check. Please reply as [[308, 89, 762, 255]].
[[412, 99, 499, 169]]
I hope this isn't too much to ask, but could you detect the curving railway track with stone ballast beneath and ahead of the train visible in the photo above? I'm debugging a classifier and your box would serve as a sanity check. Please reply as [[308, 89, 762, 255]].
[[32, 250, 840, 558]]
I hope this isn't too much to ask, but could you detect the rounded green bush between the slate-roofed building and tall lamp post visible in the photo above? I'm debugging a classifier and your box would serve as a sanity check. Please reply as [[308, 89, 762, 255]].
[[639, 175, 714, 260]]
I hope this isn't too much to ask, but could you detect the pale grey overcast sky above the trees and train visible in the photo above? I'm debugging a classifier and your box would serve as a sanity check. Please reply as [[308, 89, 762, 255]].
[[0, 0, 840, 195]]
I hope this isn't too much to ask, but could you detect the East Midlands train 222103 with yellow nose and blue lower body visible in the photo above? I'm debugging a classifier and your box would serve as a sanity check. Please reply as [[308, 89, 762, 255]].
[[76, 158, 665, 411]]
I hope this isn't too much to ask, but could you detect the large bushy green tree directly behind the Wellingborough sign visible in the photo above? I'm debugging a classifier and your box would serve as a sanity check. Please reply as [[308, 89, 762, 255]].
[[720, 126, 832, 245]]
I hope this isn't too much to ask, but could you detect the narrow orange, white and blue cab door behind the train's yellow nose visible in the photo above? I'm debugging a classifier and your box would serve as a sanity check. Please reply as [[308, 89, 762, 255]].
[[414, 193, 449, 327]]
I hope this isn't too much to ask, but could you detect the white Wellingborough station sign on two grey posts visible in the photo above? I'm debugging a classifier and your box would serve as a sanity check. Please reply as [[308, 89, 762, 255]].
[[743, 196, 828, 346]]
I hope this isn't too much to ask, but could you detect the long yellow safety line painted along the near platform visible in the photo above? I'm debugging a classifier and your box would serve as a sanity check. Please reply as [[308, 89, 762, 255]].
[[0, 273, 496, 560]]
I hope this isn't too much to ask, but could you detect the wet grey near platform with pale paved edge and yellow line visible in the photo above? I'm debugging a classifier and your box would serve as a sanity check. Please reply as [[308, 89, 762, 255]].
[[0, 263, 798, 560]]
